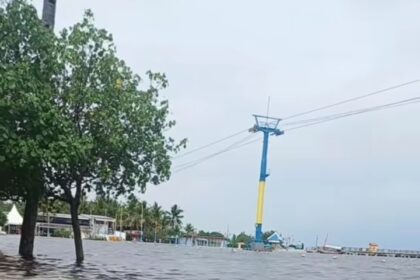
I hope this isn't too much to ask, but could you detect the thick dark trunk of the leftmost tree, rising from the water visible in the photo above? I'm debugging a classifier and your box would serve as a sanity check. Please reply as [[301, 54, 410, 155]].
[[19, 186, 41, 259]]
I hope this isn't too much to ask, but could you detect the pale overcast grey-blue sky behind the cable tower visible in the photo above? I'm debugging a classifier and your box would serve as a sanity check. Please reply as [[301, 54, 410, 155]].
[[34, 0, 420, 249]]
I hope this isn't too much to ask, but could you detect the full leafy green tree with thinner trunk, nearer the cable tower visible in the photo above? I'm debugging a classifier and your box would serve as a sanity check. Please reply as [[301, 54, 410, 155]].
[[41, 11, 185, 262]]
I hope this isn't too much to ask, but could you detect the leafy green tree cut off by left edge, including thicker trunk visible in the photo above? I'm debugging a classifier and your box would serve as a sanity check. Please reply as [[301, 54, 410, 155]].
[[0, 0, 60, 258]]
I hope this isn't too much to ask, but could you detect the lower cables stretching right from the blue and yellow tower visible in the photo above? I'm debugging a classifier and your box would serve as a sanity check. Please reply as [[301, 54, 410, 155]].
[[285, 96, 420, 131]]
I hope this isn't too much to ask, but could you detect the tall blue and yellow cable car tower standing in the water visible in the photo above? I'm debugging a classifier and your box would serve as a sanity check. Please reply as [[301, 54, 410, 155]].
[[251, 115, 284, 250]]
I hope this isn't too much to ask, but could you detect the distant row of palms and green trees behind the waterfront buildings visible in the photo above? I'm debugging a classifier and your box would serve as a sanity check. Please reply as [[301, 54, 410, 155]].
[[0, 199, 230, 243]]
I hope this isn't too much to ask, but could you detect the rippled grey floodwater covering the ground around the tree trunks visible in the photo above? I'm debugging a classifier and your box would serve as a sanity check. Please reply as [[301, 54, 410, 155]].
[[0, 236, 420, 280]]
